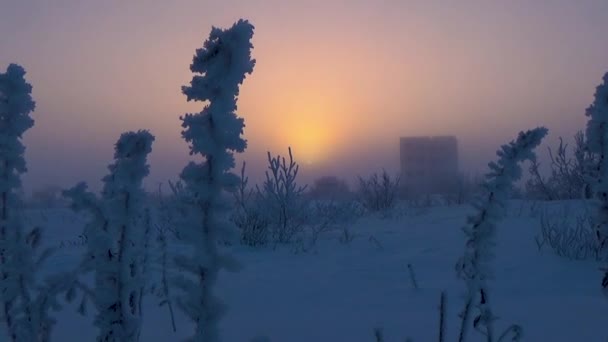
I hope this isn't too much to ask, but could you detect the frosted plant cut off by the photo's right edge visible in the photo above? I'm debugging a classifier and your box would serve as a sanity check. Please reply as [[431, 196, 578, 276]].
[[585, 73, 608, 296]]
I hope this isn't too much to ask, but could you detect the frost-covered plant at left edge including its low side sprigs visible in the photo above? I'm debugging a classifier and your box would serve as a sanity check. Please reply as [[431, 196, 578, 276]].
[[0, 64, 95, 342]]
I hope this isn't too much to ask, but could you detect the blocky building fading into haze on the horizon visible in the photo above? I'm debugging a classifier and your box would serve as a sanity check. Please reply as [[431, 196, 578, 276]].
[[400, 136, 459, 194]]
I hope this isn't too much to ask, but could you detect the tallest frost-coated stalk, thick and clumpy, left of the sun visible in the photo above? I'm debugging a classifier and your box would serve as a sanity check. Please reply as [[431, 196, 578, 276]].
[[175, 20, 255, 342]]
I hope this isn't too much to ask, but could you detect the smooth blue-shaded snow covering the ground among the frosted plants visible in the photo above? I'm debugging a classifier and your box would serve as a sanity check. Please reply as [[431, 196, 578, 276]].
[[28, 202, 608, 342]]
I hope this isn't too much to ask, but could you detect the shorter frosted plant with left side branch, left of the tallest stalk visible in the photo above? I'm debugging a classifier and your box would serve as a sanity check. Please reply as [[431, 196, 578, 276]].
[[65, 131, 154, 341]]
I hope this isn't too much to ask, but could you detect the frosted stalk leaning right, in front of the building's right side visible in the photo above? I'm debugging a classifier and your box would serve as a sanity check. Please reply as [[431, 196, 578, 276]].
[[457, 127, 547, 342]]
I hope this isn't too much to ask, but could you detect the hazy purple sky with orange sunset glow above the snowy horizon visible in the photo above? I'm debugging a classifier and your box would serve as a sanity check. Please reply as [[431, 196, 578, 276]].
[[0, 0, 608, 191]]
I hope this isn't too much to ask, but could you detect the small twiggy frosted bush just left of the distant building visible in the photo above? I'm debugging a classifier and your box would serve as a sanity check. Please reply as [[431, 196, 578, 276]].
[[358, 170, 399, 213]]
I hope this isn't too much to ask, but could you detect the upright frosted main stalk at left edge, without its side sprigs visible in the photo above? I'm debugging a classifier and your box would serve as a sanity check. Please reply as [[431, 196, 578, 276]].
[[0, 64, 42, 341]]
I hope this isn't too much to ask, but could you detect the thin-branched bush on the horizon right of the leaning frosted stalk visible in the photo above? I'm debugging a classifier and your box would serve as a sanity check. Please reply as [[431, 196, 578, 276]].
[[525, 132, 597, 201]]
